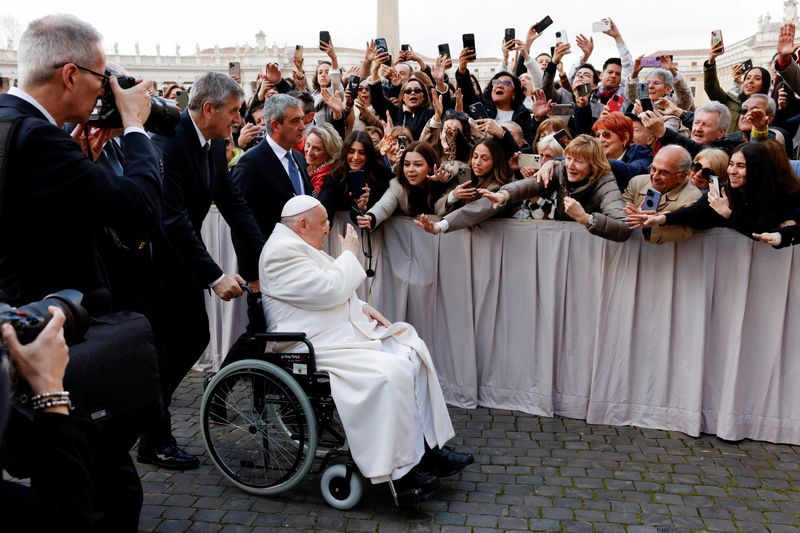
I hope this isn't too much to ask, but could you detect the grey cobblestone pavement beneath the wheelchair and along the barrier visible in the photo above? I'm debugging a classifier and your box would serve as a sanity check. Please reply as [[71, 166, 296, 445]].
[[139, 372, 800, 533]]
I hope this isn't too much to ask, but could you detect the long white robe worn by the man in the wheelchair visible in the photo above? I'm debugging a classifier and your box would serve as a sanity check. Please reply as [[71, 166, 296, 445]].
[[259, 224, 455, 482]]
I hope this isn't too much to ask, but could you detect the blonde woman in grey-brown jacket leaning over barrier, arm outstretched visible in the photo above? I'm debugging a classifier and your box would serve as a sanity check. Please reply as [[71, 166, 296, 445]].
[[417, 135, 631, 241]]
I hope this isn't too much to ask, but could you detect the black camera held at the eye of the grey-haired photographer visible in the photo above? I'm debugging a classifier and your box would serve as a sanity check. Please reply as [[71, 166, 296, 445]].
[[88, 67, 181, 135]]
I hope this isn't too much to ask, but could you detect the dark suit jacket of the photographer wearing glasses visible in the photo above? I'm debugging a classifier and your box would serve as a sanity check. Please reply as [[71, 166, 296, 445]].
[[0, 94, 161, 315]]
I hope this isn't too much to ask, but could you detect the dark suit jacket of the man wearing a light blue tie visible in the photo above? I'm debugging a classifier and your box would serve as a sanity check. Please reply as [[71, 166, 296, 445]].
[[233, 136, 314, 242]]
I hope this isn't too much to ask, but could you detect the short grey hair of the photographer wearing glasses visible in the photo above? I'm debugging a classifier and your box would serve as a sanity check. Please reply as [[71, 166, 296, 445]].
[[17, 14, 102, 87]]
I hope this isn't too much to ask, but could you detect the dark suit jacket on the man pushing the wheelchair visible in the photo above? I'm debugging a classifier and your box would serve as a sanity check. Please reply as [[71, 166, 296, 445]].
[[153, 111, 264, 288]]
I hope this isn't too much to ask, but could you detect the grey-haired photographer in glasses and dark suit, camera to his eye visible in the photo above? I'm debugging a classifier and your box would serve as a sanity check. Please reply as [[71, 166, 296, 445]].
[[0, 15, 161, 531]]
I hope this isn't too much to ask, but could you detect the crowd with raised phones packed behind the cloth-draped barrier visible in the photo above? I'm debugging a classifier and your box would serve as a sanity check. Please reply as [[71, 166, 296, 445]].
[[165, 19, 800, 246]]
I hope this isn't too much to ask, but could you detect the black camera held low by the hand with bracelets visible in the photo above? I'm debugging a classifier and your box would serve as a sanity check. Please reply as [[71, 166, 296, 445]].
[[0, 289, 89, 344]]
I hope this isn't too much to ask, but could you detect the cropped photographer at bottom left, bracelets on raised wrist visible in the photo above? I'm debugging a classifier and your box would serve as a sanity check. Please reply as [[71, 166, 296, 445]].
[[0, 306, 96, 531]]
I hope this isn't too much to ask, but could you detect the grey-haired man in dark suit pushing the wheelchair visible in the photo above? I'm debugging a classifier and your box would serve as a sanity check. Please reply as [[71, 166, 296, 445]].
[[142, 72, 264, 470]]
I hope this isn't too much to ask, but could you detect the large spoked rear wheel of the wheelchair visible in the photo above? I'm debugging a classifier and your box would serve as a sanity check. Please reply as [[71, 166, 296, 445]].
[[200, 359, 317, 495]]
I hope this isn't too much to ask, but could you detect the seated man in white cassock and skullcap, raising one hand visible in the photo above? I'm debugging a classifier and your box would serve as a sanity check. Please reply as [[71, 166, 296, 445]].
[[259, 196, 474, 496]]
